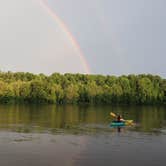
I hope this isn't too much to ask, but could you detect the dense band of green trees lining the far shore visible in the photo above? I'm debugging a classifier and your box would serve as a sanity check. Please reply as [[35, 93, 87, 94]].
[[0, 72, 166, 104]]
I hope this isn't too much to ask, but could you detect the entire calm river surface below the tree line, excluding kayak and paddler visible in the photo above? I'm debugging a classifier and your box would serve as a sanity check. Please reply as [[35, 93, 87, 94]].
[[0, 105, 166, 166]]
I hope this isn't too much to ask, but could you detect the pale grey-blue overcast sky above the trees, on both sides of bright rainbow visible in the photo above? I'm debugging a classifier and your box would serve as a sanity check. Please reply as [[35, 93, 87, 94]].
[[0, 0, 166, 77]]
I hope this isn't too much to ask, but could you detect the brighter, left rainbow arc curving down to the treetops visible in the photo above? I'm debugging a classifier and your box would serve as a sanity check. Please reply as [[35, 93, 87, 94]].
[[39, 0, 91, 74]]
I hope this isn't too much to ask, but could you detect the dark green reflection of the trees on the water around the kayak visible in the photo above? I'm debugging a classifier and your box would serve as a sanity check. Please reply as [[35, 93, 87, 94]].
[[0, 105, 166, 134]]
